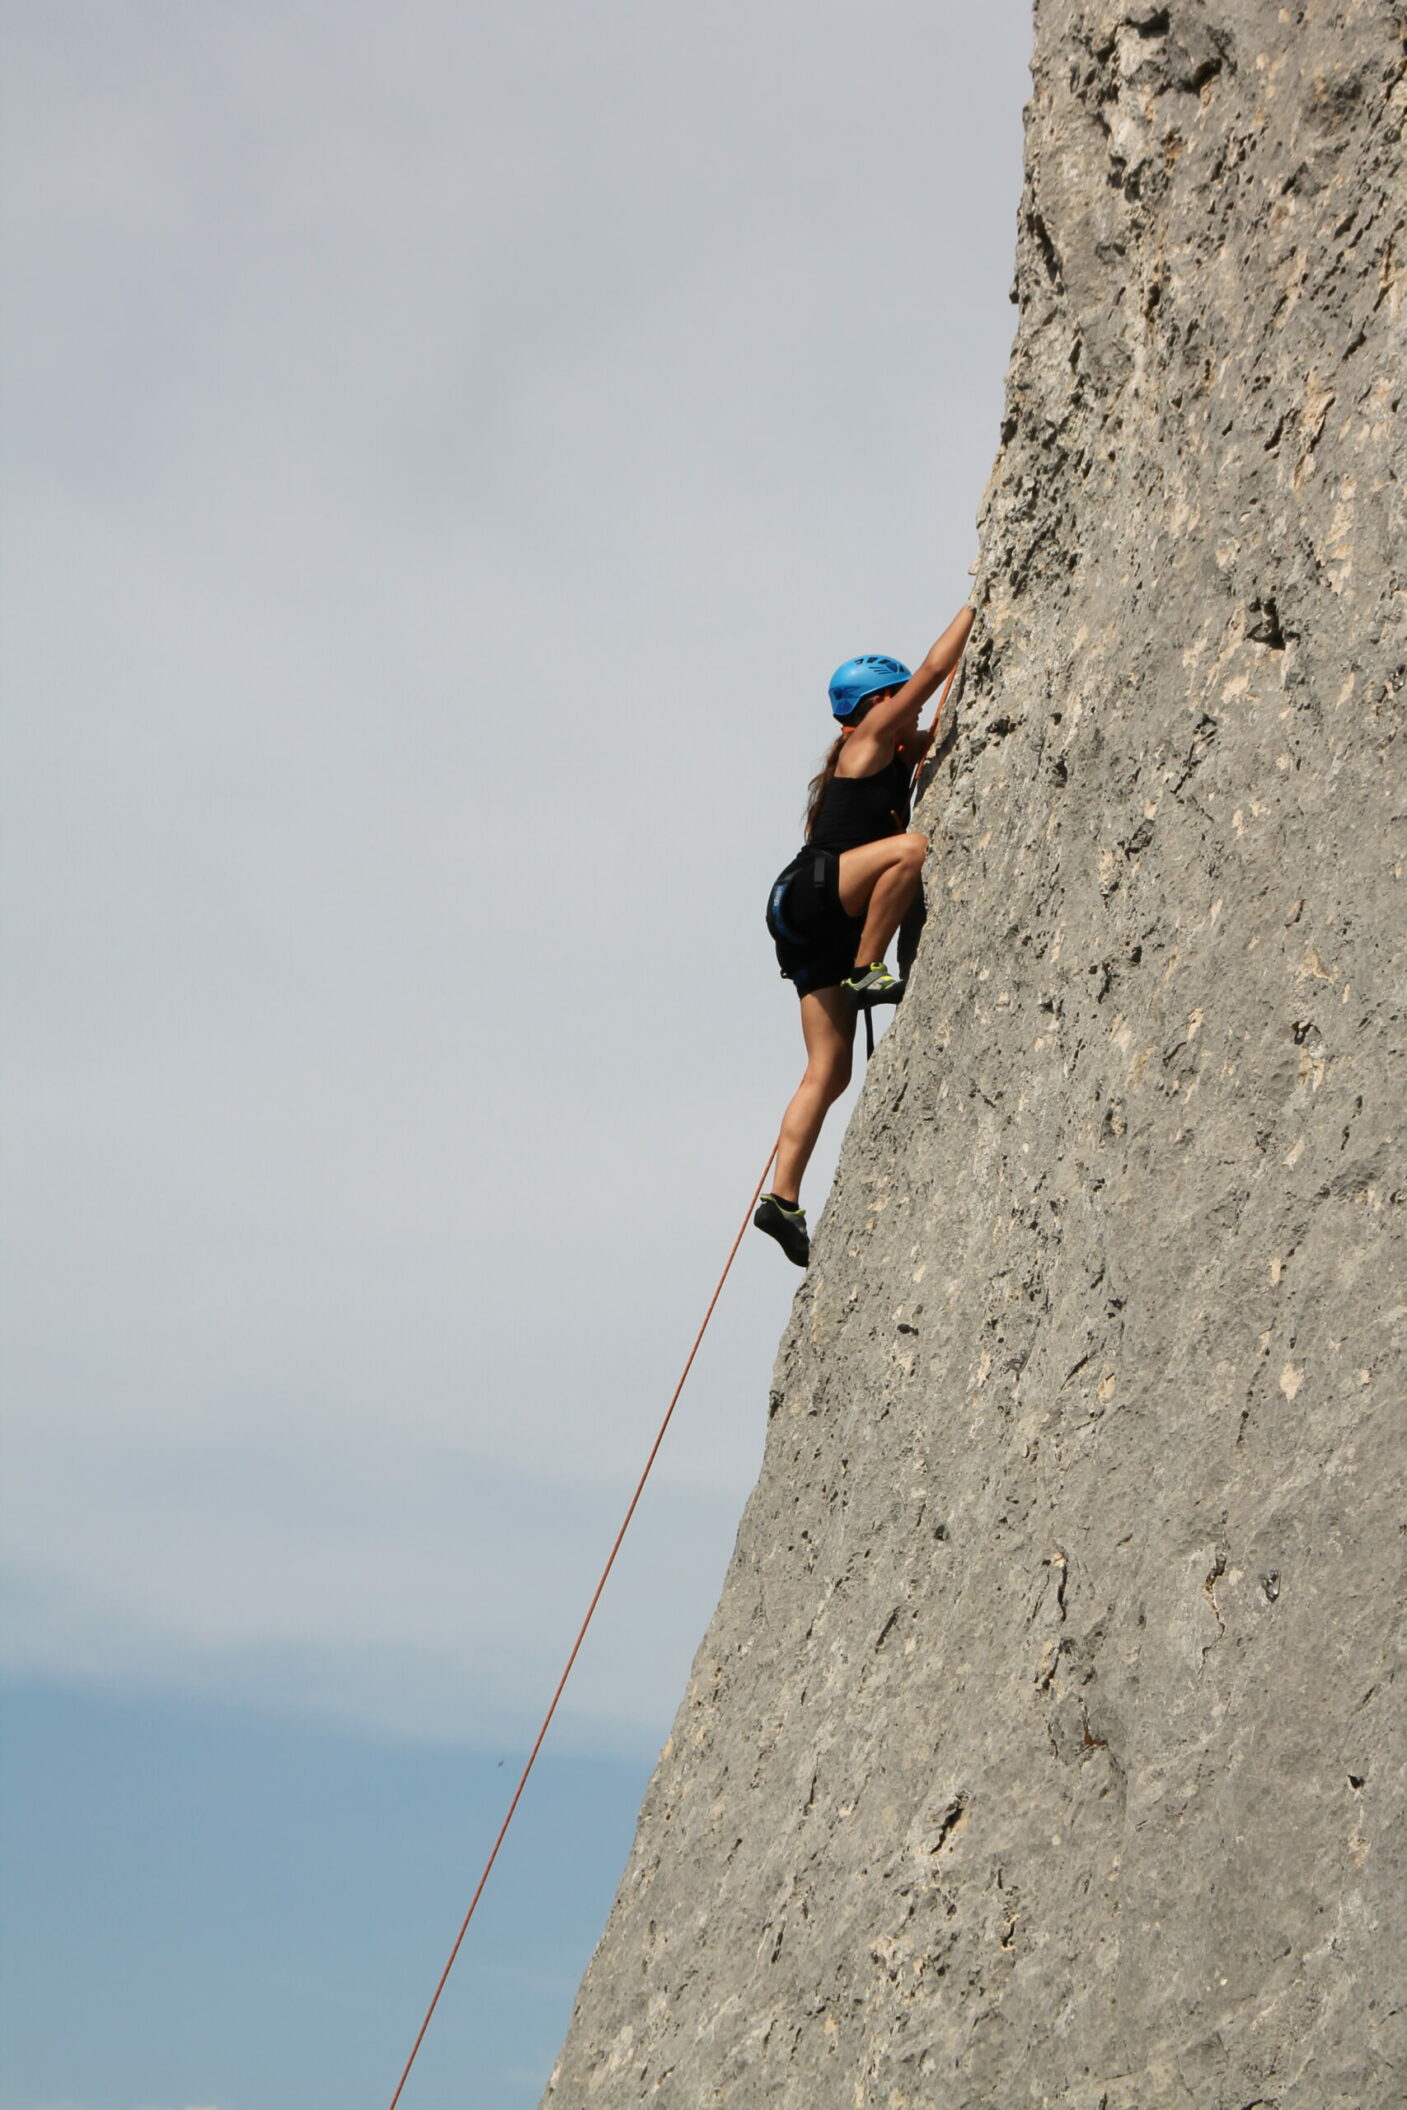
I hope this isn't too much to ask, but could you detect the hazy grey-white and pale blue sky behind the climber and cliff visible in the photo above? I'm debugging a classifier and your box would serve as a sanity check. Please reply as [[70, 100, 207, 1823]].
[[0, 0, 1029, 2110]]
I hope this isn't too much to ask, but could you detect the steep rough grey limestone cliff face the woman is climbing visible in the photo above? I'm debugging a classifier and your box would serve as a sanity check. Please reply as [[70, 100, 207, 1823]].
[[546, 0, 1407, 2110]]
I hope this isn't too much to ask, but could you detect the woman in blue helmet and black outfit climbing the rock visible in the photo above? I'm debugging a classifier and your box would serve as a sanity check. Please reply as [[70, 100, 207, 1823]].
[[753, 608, 972, 1268]]
